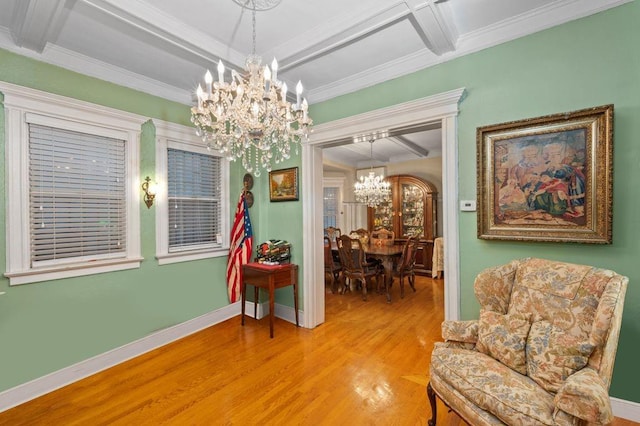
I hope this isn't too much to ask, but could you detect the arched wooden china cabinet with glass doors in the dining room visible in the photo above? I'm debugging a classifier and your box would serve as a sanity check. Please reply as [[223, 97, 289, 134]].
[[367, 175, 438, 275]]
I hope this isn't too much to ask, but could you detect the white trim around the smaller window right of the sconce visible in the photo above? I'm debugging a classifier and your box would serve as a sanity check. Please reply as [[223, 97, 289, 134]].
[[153, 120, 230, 265]]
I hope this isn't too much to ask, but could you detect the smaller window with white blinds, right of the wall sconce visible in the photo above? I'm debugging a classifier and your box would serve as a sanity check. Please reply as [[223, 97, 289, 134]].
[[167, 148, 222, 252]]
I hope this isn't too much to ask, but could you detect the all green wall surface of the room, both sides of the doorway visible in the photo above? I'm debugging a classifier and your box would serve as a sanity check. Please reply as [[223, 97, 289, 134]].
[[0, 2, 640, 402]]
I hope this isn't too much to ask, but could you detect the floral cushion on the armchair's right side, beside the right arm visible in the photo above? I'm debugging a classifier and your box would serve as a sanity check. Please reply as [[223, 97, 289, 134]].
[[526, 321, 594, 392]]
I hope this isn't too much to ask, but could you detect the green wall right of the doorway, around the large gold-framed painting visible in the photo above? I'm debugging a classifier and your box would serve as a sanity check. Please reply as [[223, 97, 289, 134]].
[[311, 2, 640, 402]]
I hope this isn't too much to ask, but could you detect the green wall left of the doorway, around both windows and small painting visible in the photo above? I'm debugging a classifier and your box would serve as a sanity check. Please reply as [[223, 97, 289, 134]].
[[0, 50, 302, 391]]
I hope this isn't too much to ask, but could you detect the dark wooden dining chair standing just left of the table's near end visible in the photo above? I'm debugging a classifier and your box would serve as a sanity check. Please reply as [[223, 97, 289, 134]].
[[338, 235, 382, 301]]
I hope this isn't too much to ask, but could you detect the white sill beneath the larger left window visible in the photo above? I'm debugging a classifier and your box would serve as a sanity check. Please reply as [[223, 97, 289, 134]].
[[4, 257, 143, 285]]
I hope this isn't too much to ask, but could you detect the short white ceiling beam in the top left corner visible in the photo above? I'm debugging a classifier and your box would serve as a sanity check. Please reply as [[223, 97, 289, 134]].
[[10, 0, 70, 53]]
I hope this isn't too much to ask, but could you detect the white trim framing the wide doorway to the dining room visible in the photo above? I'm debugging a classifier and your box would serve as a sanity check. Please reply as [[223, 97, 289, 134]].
[[302, 88, 465, 328]]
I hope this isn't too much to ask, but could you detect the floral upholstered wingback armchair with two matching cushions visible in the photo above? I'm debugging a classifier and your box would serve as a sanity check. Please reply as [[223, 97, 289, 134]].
[[427, 258, 629, 426]]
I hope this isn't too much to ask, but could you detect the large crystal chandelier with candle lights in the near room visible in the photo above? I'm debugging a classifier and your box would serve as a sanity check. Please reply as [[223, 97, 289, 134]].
[[191, 0, 313, 177]]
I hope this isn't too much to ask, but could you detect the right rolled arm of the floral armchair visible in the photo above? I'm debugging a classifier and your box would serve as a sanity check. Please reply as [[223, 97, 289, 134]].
[[553, 368, 613, 424]]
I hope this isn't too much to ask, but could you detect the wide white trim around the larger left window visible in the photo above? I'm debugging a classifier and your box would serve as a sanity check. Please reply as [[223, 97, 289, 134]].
[[0, 82, 146, 285]]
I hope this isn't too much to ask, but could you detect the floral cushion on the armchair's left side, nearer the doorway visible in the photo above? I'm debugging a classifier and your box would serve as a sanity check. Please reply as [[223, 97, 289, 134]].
[[476, 310, 531, 374]]
